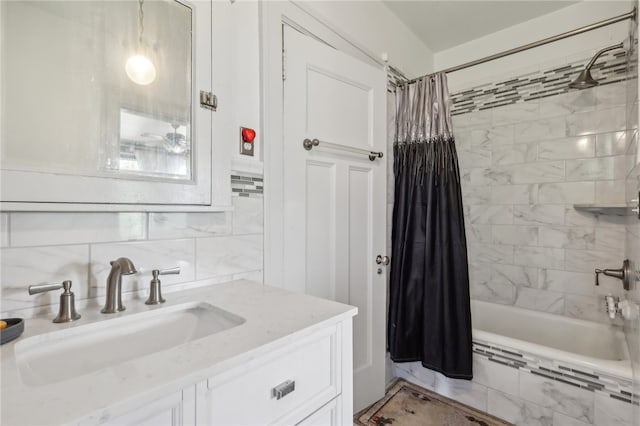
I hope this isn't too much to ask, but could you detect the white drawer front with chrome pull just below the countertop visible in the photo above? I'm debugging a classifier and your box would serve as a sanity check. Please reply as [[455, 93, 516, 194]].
[[207, 327, 340, 426]]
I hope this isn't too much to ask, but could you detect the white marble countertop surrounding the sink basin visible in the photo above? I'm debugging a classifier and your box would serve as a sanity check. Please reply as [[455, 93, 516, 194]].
[[0, 280, 357, 426]]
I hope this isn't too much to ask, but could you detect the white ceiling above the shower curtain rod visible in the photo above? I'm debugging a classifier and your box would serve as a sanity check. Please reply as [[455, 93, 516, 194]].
[[382, 0, 579, 53]]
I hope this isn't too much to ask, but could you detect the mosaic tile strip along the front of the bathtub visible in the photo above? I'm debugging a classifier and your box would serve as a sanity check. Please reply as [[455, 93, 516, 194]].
[[473, 340, 640, 405]]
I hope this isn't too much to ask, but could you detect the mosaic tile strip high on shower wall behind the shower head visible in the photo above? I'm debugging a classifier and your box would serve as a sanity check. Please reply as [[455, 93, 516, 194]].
[[451, 50, 627, 115]]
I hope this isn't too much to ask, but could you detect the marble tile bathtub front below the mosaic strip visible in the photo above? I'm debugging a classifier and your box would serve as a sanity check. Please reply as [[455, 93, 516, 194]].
[[392, 353, 637, 426]]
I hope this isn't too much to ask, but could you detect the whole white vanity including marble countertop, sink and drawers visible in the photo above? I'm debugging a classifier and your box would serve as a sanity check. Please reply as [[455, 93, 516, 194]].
[[0, 280, 357, 426]]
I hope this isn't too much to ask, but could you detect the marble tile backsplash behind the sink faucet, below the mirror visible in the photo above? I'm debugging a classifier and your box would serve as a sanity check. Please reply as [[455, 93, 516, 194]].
[[0, 173, 263, 317]]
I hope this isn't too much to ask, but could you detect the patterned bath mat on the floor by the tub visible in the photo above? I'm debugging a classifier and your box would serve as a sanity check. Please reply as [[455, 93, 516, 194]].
[[354, 379, 512, 426]]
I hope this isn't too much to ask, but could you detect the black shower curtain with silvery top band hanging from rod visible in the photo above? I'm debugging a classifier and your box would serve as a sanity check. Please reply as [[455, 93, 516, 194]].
[[388, 73, 473, 379]]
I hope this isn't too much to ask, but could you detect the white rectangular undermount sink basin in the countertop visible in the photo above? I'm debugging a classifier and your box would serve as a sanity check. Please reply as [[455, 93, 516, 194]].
[[15, 302, 245, 386]]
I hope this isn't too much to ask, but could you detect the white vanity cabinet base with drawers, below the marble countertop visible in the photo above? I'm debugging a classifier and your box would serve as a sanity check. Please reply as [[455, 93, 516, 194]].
[[98, 318, 353, 426]]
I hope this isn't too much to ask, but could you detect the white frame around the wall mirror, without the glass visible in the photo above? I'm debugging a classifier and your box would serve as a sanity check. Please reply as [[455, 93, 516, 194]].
[[0, 0, 225, 211]]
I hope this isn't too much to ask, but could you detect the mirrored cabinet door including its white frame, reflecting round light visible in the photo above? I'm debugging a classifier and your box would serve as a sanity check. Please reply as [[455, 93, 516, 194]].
[[0, 0, 211, 208]]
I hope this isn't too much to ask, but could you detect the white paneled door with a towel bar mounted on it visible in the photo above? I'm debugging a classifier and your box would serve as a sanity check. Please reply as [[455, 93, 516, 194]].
[[283, 27, 386, 411]]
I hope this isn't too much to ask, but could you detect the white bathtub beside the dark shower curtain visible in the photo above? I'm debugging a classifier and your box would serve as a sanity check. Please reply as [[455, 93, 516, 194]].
[[471, 300, 632, 381]]
